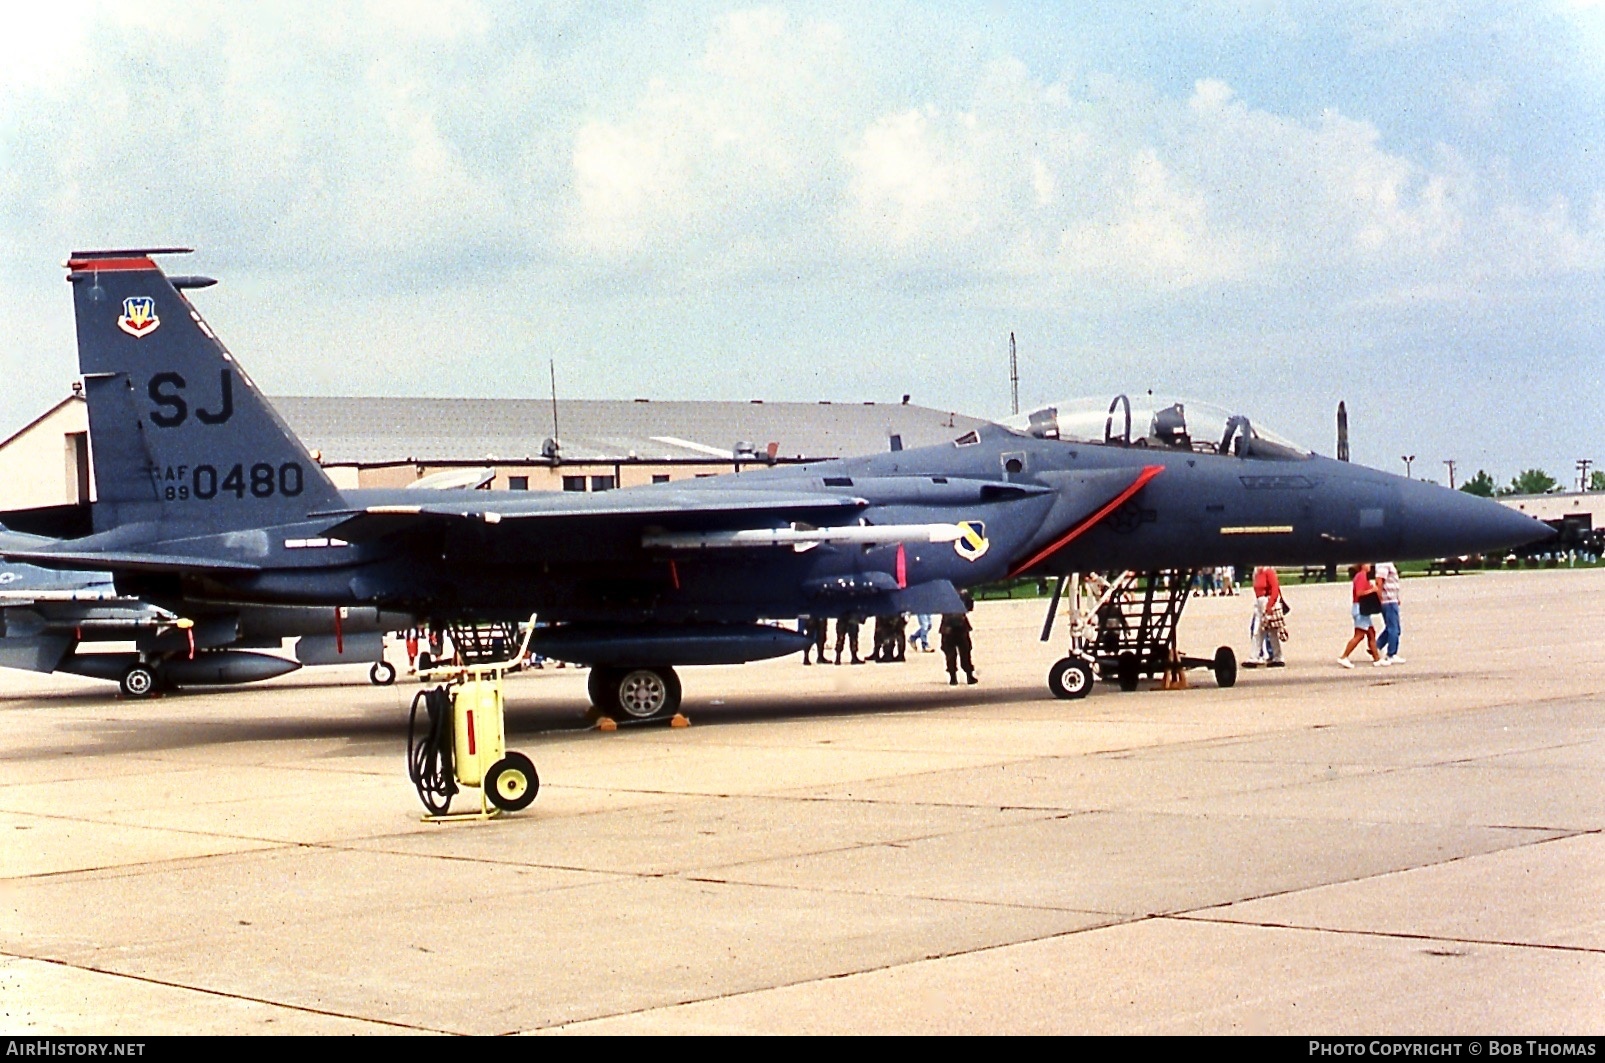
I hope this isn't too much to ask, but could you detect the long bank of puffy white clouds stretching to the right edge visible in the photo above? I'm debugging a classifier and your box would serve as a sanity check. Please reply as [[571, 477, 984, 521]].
[[568, 23, 1599, 299]]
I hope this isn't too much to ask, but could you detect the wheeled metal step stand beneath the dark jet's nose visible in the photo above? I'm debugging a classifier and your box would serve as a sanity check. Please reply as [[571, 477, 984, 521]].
[[1042, 568, 1237, 698]]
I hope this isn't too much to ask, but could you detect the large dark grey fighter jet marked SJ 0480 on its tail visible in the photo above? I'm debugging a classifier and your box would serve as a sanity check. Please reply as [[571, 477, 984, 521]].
[[0, 249, 1549, 718]]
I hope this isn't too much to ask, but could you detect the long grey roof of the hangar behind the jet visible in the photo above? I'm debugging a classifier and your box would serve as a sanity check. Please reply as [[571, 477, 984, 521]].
[[271, 397, 985, 466]]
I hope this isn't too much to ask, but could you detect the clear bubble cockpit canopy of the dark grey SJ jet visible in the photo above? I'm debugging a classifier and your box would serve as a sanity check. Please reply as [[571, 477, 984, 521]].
[[1003, 393, 1310, 461]]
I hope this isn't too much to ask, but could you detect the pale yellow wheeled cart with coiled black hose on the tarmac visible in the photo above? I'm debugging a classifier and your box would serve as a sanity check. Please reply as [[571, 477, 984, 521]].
[[408, 618, 541, 821]]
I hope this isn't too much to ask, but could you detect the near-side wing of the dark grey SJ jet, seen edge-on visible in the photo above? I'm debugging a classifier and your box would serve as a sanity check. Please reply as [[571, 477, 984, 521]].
[[319, 490, 868, 543]]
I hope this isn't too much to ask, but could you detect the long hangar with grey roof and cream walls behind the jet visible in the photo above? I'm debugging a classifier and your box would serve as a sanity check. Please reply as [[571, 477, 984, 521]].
[[0, 389, 984, 509]]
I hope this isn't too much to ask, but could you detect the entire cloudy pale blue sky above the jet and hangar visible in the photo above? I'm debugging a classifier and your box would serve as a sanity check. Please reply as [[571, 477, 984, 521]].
[[0, 0, 1605, 483]]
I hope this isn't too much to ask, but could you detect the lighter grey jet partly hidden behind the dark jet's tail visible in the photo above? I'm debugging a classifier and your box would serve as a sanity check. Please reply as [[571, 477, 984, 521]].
[[0, 527, 412, 697]]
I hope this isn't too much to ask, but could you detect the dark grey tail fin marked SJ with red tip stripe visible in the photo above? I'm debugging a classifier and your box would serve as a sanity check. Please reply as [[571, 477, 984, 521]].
[[67, 247, 340, 532]]
